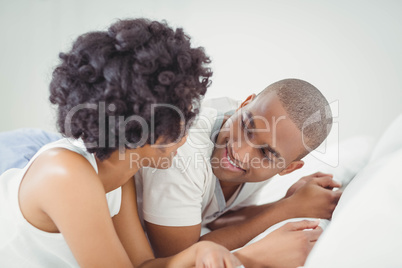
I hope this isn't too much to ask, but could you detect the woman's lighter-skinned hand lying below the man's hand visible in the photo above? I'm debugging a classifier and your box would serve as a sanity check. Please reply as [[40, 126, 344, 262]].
[[235, 220, 322, 268]]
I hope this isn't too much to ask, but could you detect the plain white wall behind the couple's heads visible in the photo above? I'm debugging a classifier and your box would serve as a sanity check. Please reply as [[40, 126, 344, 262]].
[[0, 0, 402, 138]]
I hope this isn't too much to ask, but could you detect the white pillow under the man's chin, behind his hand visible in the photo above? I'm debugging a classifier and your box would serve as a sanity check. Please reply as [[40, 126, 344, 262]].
[[258, 136, 374, 204]]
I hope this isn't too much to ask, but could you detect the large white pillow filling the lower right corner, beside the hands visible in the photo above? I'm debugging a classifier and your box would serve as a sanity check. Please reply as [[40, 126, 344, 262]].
[[305, 149, 402, 268]]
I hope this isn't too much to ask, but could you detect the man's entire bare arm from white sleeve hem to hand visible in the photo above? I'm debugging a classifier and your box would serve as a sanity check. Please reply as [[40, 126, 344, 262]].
[[146, 174, 341, 256]]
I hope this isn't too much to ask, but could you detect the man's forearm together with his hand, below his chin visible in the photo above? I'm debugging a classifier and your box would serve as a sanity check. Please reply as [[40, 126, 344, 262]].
[[201, 173, 342, 250]]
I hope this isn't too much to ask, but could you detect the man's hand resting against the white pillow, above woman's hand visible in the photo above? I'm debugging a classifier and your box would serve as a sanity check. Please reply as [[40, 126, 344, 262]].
[[285, 173, 342, 219]]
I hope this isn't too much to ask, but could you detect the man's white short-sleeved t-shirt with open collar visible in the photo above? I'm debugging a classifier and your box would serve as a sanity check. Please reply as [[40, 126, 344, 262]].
[[135, 107, 268, 226]]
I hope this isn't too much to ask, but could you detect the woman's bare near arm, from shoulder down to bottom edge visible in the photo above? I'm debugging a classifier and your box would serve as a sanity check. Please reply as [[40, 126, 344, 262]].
[[35, 150, 132, 267]]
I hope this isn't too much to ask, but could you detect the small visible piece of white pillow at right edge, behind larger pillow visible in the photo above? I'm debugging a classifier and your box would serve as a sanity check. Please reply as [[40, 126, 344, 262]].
[[370, 114, 402, 162]]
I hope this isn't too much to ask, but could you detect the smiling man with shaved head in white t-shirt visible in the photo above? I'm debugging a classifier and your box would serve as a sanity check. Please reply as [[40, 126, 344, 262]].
[[136, 79, 341, 257]]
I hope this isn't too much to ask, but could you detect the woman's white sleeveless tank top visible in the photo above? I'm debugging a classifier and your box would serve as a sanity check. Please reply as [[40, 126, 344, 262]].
[[0, 139, 121, 268]]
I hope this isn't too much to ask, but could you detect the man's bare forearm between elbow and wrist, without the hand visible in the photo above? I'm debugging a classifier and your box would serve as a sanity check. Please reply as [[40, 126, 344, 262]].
[[200, 199, 291, 250]]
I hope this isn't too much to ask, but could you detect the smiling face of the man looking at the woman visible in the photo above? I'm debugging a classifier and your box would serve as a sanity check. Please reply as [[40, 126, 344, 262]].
[[211, 93, 305, 184]]
